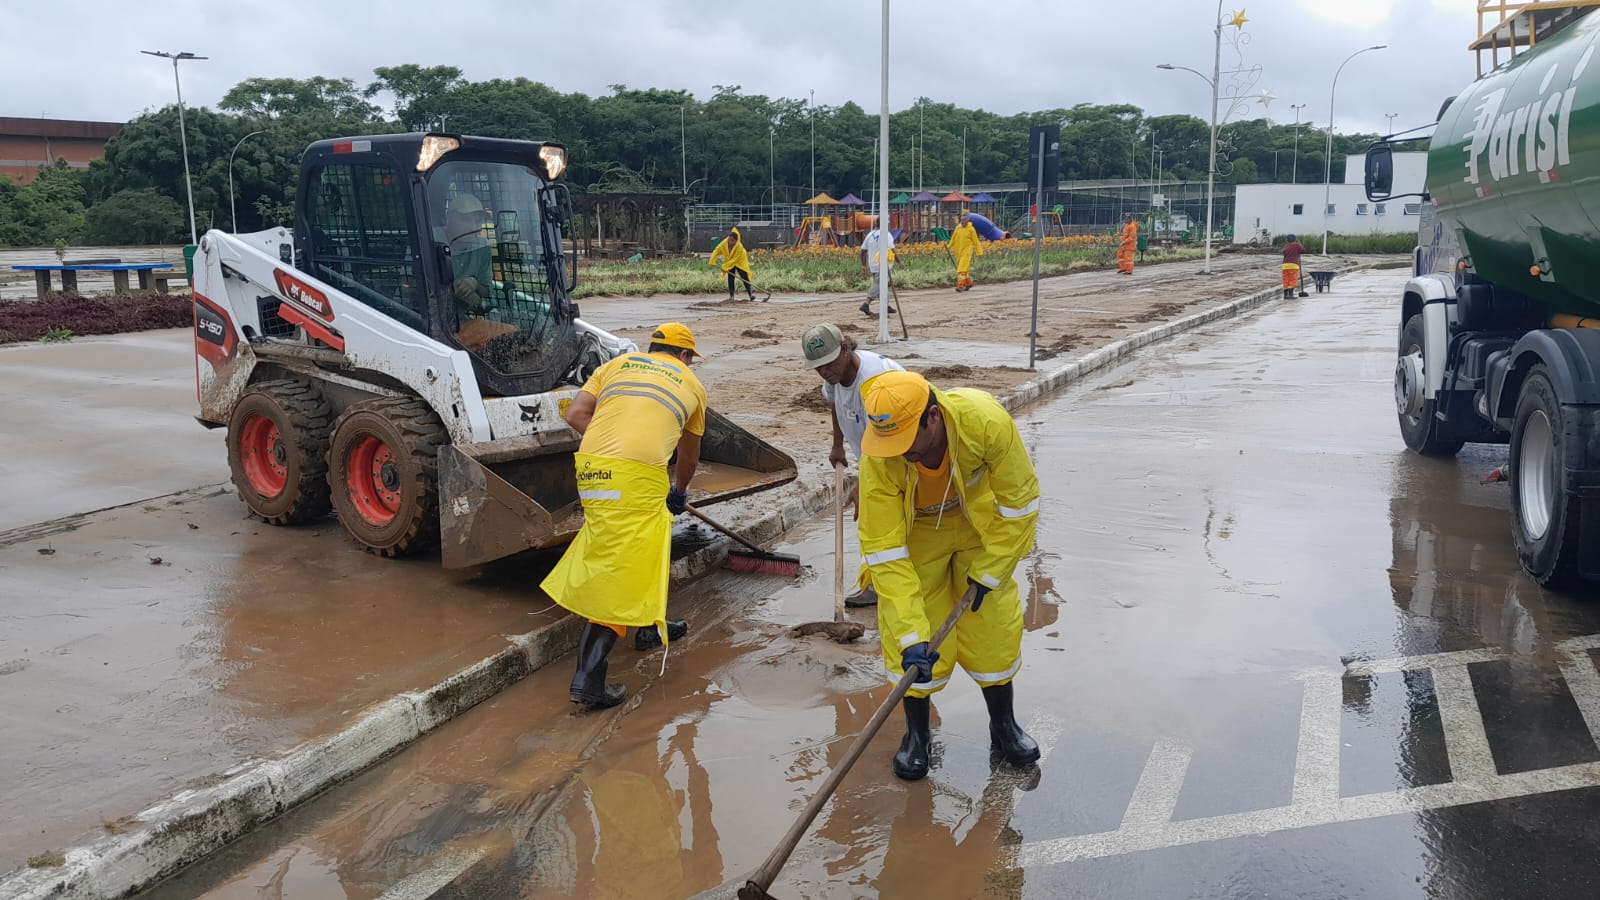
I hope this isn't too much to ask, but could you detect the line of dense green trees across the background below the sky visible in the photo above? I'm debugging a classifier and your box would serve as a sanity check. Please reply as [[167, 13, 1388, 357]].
[[0, 64, 1373, 247]]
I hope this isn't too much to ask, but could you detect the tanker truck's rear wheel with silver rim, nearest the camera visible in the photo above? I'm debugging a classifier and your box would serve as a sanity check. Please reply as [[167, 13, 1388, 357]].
[[1510, 365, 1579, 588]]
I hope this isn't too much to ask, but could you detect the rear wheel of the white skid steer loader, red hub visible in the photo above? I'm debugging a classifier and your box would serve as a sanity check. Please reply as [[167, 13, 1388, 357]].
[[227, 381, 333, 525]]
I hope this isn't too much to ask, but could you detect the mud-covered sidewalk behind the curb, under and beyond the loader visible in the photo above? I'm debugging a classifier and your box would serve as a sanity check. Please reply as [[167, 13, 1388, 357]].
[[0, 248, 1358, 871]]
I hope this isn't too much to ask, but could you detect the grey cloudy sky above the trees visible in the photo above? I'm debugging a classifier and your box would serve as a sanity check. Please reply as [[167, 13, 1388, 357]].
[[12, 0, 1477, 131]]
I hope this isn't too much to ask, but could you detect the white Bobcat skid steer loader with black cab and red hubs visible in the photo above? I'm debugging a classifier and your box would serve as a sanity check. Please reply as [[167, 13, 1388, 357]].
[[194, 133, 795, 569]]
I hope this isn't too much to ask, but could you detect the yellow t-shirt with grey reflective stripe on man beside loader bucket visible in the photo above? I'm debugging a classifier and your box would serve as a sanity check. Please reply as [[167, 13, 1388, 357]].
[[579, 354, 706, 466]]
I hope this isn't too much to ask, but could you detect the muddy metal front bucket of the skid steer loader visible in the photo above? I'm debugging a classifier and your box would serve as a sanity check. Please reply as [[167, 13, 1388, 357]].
[[438, 412, 797, 569]]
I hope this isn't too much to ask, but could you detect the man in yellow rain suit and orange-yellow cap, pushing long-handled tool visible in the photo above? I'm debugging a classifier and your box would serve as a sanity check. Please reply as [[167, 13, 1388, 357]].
[[858, 372, 1038, 781]]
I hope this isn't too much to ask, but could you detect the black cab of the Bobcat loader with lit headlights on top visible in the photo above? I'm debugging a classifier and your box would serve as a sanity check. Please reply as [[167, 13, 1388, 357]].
[[294, 135, 582, 396]]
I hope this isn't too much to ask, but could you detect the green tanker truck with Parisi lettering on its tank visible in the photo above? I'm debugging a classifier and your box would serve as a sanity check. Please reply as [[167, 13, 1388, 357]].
[[1365, 13, 1600, 588]]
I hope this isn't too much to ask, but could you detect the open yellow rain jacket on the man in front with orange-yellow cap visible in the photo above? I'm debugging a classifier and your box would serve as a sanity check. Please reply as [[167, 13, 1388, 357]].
[[858, 381, 1038, 646]]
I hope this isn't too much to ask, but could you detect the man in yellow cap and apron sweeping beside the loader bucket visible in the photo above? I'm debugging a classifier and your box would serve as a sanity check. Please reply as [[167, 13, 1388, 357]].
[[542, 322, 706, 706]]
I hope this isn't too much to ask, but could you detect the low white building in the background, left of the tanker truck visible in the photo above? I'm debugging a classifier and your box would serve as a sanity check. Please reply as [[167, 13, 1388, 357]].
[[1234, 152, 1427, 245]]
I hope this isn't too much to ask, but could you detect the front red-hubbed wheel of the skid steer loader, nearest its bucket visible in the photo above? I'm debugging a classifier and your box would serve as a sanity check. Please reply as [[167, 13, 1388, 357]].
[[328, 397, 450, 556]]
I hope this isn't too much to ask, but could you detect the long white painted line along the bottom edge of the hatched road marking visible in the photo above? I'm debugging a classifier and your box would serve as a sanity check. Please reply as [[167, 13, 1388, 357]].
[[1019, 762, 1600, 868]]
